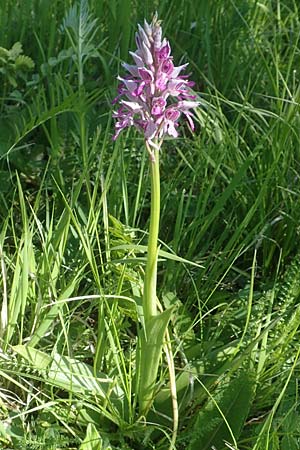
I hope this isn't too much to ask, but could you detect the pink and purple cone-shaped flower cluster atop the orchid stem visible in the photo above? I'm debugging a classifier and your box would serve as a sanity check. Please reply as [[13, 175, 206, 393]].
[[113, 15, 198, 147]]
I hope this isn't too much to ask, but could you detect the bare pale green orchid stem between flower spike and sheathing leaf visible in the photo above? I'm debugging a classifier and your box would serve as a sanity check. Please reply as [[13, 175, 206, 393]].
[[143, 144, 160, 324]]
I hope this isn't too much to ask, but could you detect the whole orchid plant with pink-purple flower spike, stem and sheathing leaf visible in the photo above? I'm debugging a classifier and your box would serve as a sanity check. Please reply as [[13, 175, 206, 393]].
[[113, 14, 199, 415]]
